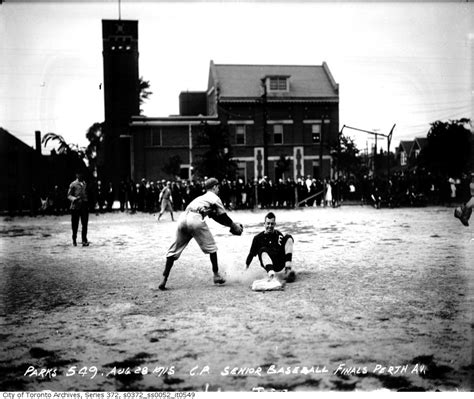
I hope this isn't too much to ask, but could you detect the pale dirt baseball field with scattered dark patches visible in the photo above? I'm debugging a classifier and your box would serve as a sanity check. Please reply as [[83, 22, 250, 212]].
[[0, 206, 474, 391]]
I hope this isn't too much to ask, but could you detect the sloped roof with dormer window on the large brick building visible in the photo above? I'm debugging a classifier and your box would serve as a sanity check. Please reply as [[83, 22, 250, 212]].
[[208, 61, 339, 100]]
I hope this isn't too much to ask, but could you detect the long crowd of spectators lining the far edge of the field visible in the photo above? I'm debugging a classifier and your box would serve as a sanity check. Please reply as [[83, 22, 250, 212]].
[[8, 171, 471, 215]]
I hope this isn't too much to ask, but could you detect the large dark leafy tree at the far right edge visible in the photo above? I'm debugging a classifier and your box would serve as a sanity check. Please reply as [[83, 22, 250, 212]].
[[417, 118, 472, 177]]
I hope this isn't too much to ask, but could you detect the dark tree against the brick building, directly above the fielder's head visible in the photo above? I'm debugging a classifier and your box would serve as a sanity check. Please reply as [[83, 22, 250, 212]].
[[193, 122, 237, 180]]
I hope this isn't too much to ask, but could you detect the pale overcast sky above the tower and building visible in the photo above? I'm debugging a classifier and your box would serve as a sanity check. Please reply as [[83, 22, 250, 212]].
[[0, 0, 474, 153]]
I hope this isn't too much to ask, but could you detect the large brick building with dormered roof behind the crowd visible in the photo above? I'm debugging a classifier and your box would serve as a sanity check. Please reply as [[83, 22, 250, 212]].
[[130, 61, 339, 181]]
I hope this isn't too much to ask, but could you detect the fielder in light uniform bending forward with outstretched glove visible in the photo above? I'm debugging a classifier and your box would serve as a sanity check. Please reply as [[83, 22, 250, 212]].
[[158, 177, 243, 290]]
